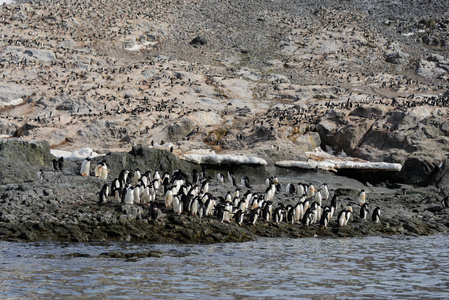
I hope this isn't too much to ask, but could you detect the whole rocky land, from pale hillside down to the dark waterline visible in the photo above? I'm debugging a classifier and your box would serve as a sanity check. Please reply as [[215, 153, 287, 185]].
[[0, 0, 449, 242]]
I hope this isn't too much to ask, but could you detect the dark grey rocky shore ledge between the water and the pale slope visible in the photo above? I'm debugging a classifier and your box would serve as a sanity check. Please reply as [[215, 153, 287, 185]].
[[0, 140, 449, 243]]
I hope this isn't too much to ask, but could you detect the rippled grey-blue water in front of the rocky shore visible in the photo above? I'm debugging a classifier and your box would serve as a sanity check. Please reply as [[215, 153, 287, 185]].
[[0, 236, 449, 299]]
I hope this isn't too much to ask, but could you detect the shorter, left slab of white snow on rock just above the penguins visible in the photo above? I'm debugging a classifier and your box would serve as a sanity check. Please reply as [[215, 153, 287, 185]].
[[183, 154, 267, 165]]
